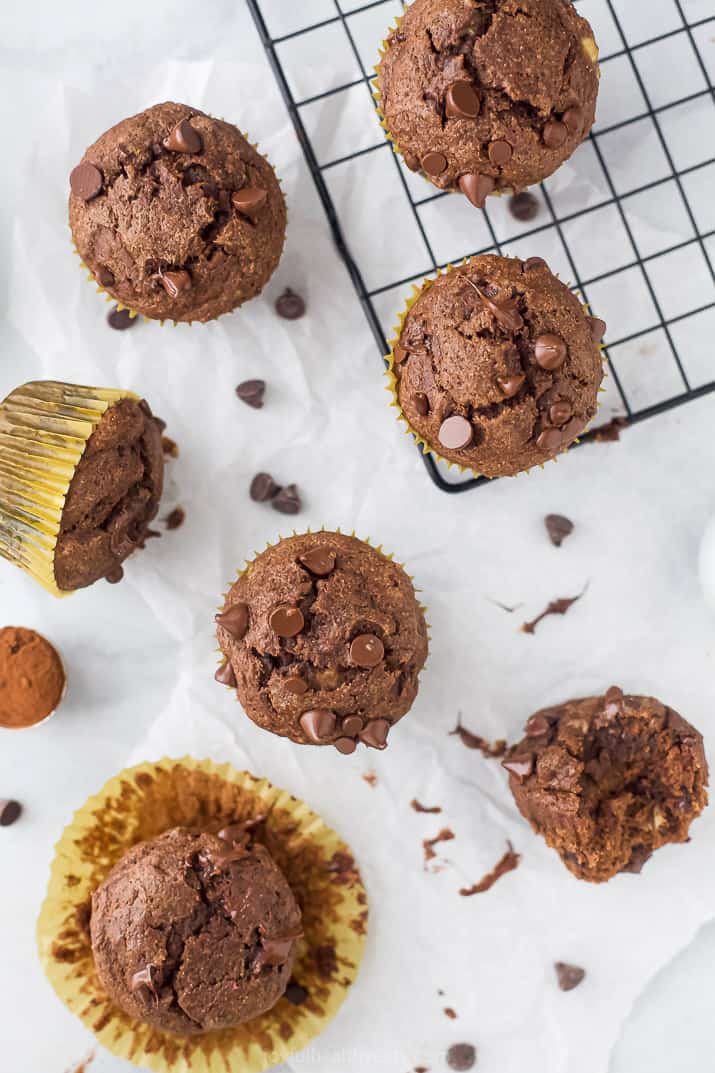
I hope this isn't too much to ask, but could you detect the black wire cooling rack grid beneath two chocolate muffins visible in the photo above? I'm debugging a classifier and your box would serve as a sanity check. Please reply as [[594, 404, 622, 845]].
[[248, 0, 715, 493]]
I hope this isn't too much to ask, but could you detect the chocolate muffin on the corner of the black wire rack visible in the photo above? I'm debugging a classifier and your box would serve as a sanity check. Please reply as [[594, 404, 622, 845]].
[[392, 255, 605, 476]]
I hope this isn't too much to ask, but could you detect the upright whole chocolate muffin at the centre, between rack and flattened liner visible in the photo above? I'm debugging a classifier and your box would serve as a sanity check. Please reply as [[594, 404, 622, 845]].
[[216, 532, 427, 753]]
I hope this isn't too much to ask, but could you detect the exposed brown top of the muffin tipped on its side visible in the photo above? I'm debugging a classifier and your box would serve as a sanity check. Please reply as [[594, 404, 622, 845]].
[[55, 398, 164, 591]]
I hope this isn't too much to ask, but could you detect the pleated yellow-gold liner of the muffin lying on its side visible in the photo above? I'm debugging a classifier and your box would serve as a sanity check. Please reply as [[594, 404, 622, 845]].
[[0, 380, 138, 597]]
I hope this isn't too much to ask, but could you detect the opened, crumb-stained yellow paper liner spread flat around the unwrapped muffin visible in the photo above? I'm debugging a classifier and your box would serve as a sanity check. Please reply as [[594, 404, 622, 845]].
[[38, 756, 367, 1073]]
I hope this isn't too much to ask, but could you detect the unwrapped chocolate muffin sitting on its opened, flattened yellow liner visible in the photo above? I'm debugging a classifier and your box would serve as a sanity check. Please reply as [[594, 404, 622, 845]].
[[90, 827, 302, 1035]]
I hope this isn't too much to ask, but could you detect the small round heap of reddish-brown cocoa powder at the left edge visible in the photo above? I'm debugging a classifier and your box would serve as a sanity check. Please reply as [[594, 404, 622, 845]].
[[0, 626, 64, 730]]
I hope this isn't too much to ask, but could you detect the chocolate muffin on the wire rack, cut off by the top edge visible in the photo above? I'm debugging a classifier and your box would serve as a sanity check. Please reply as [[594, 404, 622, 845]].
[[377, 0, 599, 208]]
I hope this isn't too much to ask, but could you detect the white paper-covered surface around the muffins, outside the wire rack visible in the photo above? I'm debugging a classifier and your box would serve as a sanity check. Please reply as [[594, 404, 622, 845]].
[[0, 0, 715, 1073]]
